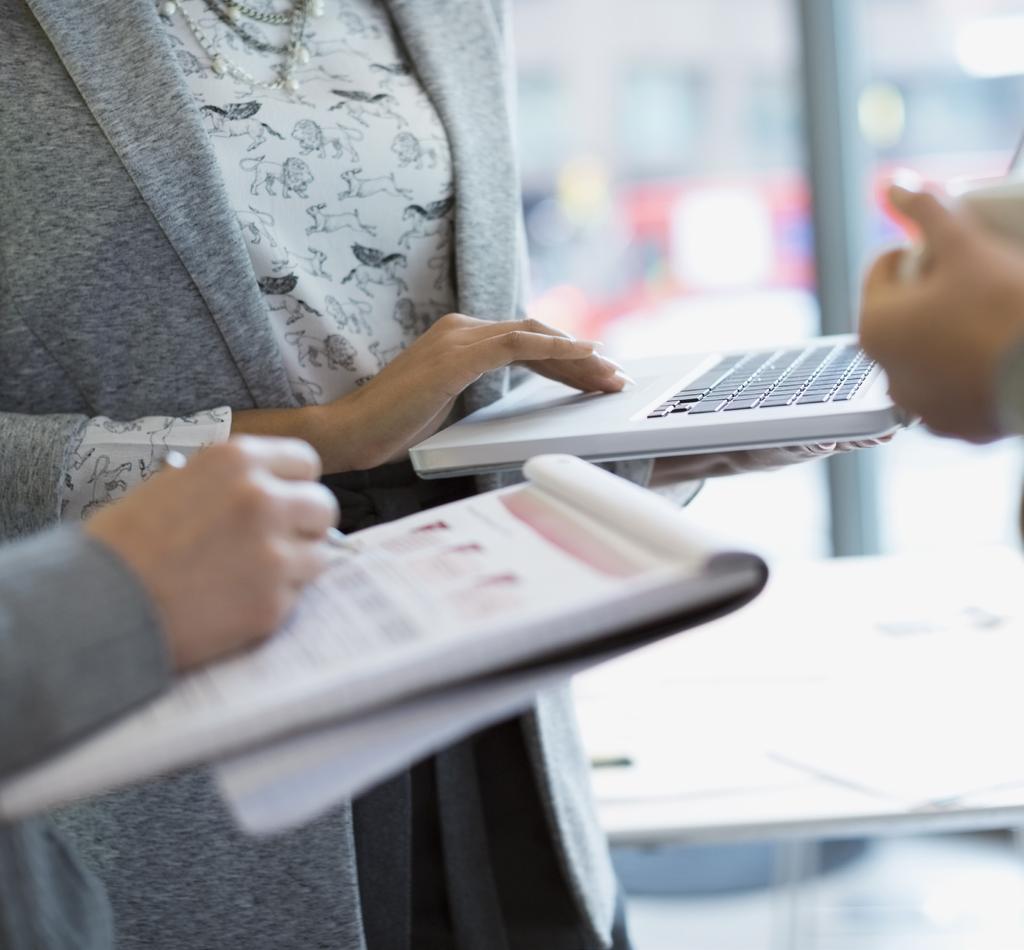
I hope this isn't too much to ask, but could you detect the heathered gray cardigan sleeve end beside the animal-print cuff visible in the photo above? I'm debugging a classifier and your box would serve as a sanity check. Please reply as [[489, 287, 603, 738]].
[[0, 413, 88, 541]]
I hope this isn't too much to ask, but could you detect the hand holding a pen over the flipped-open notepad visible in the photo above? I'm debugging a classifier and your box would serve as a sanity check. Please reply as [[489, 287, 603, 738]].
[[85, 438, 338, 670]]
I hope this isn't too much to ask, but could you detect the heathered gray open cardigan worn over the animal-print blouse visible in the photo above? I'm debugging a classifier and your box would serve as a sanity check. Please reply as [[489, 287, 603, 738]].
[[0, 0, 644, 950]]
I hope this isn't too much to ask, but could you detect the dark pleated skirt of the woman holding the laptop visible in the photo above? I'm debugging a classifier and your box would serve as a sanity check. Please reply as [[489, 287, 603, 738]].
[[325, 464, 631, 950]]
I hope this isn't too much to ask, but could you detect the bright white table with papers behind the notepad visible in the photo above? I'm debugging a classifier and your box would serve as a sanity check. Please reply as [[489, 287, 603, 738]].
[[575, 549, 1024, 947]]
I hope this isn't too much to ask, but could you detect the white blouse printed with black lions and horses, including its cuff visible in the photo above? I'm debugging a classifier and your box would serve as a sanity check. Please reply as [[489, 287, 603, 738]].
[[62, 0, 455, 518]]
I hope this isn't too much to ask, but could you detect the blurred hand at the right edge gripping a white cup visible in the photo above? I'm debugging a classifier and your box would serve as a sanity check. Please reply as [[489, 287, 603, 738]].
[[860, 187, 1024, 442]]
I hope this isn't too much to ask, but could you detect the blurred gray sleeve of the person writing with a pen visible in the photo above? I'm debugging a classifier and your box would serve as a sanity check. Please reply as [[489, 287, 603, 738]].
[[0, 528, 171, 775]]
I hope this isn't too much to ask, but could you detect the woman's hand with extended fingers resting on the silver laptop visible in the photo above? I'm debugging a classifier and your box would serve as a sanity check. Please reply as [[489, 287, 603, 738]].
[[232, 313, 628, 473]]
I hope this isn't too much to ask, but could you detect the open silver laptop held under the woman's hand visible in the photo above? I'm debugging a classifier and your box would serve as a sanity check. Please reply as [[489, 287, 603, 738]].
[[410, 336, 906, 478]]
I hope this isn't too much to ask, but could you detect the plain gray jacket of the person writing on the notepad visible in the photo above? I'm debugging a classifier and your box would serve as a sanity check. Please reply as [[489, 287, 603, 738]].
[[0, 529, 171, 950]]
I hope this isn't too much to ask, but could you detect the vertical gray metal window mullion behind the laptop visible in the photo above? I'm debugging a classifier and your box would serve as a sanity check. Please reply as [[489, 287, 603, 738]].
[[797, 0, 880, 556]]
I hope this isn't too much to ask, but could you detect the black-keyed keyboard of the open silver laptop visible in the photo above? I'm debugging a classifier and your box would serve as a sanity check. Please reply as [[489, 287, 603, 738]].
[[647, 343, 874, 419]]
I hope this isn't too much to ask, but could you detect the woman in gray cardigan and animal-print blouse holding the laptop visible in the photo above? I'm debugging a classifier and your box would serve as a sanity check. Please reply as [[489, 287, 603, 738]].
[[0, 0, 839, 950]]
